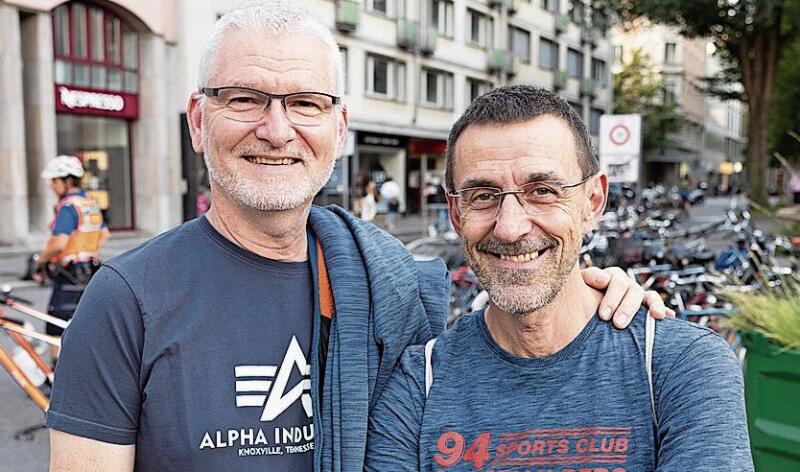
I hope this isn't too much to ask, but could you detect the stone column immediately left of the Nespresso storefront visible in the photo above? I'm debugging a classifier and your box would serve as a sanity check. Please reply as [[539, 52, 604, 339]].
[[21, 13, 56, 236]]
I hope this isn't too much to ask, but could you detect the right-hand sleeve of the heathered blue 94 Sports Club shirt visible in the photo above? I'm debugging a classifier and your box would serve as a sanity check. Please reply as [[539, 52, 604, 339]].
[[654, 333, 753, 472]]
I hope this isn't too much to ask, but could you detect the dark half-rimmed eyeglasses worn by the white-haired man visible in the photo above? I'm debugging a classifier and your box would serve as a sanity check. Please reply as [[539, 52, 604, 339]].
[[200, 87, 341, 126]]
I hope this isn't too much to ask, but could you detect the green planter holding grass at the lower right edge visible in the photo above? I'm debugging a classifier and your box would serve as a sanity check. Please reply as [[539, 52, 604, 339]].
[[742, 331, 800, 472]]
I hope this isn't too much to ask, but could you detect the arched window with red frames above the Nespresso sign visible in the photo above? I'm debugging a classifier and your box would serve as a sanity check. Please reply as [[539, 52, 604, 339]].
[[53, 2, 139, 93]]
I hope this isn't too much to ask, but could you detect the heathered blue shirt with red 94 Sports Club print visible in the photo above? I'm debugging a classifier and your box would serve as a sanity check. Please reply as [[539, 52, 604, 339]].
[[366, 311, 753, 472]]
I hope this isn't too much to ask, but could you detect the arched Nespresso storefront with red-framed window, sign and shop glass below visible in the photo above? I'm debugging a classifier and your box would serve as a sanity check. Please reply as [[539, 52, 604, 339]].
[[52, 2, 139, 229]]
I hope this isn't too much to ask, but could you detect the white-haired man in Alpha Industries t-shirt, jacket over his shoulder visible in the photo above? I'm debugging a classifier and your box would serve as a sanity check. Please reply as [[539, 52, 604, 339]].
[[47, 0, 664, 472]]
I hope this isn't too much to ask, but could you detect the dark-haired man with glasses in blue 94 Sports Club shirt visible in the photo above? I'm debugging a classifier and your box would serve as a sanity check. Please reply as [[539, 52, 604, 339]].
[[366, 85, 753, 472]]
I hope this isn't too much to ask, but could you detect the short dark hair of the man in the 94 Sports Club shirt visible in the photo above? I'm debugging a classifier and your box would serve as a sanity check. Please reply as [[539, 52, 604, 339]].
[[445, 85, 600, 192]]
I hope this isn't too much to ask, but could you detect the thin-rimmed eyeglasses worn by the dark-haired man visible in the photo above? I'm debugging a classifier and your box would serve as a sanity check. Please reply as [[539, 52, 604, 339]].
[[449, 175, 593, 220]]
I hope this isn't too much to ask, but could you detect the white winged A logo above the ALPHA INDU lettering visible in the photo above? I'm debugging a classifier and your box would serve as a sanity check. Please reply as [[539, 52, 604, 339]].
[[234, 336, 312, 421]]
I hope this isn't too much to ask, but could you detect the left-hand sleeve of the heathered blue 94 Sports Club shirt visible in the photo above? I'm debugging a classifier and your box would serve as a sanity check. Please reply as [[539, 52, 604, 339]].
[[365, 346, 425, 472]]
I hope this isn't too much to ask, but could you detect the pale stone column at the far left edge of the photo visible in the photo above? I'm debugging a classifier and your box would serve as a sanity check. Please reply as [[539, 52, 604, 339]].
[[0, 3, 28, 244]]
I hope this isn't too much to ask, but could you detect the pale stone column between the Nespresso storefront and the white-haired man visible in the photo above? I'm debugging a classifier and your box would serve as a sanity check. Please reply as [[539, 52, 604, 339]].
[[132, 33, 183, 234]]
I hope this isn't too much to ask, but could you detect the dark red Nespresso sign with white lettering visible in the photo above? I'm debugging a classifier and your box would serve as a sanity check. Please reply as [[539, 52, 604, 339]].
[[55, 85, 139, 119]]
